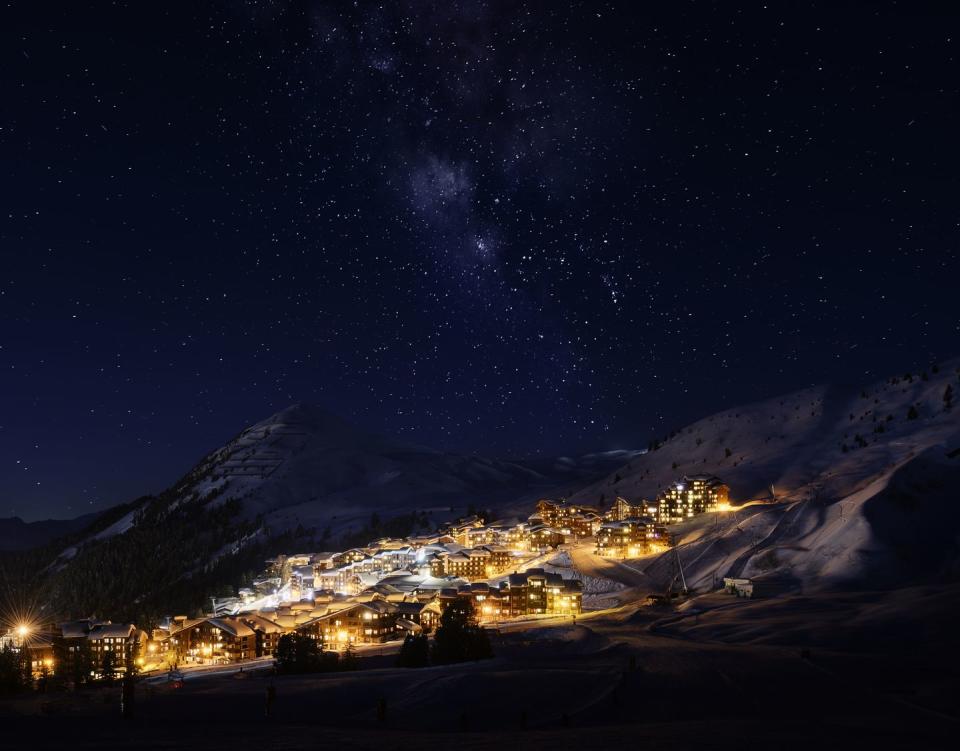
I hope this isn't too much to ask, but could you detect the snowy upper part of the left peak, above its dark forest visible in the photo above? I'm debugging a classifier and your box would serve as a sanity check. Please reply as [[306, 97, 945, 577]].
[[100, 404, 637, 536]]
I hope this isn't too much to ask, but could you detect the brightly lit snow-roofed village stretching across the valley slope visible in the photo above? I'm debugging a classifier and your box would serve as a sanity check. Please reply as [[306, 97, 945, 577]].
[[0, 475, 743, 680]]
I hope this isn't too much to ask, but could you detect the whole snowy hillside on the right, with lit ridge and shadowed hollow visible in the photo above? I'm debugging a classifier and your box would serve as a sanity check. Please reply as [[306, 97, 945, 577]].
[[577, 361, 960, 591]]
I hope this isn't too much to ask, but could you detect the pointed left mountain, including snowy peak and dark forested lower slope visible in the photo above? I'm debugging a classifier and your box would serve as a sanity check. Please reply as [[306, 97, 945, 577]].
[[19, 405, 630, 623]]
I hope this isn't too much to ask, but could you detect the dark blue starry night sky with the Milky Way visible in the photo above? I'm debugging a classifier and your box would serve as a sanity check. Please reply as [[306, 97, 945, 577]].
[[0, 0, 960, 519]]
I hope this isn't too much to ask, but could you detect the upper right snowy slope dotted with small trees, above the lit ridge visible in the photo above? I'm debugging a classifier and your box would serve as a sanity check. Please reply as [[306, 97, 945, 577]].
[[575, 361, 960, 502]]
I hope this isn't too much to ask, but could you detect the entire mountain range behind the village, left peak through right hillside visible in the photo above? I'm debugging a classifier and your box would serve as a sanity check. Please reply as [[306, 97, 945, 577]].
[[20, 360, 960, 617]]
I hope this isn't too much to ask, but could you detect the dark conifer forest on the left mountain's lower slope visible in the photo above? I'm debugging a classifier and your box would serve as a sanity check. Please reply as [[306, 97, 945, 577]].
[[0, 494, 307, 628]]
